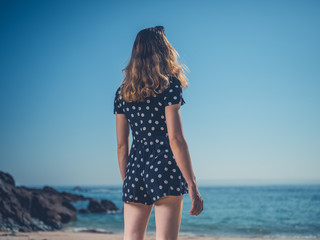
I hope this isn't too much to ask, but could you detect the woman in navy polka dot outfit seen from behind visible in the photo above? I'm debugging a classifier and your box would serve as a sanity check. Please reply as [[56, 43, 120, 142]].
[[114, 26, 203, 240]]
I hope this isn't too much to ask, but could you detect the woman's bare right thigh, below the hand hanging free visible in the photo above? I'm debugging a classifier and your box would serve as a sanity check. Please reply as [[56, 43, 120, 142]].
[[154, 195, 183, 240]]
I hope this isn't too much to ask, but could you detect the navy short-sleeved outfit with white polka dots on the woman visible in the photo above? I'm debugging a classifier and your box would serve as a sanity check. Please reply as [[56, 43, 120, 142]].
[[114, 76, 188, 205]]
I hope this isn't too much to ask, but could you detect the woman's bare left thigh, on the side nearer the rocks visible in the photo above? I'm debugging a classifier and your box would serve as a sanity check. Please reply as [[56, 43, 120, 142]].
[[123, 202, 153, 240]]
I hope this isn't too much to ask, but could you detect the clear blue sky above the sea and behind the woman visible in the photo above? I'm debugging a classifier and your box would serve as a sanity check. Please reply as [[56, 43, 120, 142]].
[[0, 0, 320, 185]]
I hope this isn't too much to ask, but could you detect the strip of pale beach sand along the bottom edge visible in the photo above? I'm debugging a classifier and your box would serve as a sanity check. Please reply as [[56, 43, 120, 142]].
[[0, 231, 316, 240]]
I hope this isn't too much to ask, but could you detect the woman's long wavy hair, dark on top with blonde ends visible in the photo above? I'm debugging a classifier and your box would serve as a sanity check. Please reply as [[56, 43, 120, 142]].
[[120, 26, 189, 102]]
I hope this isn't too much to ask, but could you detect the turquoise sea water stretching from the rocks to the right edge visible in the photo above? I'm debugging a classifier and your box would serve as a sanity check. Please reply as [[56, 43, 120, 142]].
[[43, 185, 320, 238]]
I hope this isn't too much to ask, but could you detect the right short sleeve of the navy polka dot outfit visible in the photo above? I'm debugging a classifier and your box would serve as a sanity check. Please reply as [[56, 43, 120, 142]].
[[164, 77, 186, 106]]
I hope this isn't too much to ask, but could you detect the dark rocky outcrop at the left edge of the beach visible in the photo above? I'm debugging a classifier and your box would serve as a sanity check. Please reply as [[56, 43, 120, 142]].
[[0, 171, 119, 232]]
